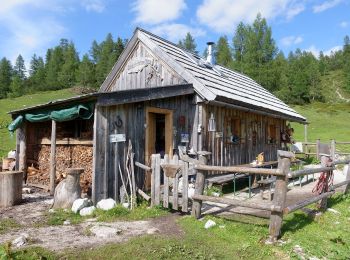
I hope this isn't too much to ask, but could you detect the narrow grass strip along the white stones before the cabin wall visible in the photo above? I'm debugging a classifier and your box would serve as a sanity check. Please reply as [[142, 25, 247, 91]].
[[45, 203, 169, 225]]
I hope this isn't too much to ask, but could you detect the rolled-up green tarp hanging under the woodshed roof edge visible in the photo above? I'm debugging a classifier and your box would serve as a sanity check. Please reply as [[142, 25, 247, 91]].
[[8, 103, 94, 132]]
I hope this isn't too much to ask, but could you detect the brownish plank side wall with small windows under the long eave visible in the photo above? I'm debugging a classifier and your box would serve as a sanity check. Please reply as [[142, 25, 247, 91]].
[[202, 105, 286, 166]]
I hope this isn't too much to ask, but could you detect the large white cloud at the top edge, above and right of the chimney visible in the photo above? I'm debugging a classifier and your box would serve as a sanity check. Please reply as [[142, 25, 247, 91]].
[[197, 0, 305, 33]]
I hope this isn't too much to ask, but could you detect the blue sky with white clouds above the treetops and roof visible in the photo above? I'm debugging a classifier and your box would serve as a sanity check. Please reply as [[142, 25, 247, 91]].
[[0, 0, 350, 67]]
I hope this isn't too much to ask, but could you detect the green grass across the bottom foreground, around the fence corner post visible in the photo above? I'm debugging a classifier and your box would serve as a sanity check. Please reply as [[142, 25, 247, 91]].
[[6, 194, 350, 259]]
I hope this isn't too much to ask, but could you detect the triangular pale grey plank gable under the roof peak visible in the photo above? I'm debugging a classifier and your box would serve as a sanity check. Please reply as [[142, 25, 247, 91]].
[[107, 42, 185, 91]]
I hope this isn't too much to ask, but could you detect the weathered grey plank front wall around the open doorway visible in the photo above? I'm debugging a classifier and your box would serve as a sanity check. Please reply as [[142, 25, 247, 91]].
[[93, 95, 196, 201]]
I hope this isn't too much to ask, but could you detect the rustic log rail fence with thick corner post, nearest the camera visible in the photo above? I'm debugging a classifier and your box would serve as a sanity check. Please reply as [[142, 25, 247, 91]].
[[192, 151, 350, 243]]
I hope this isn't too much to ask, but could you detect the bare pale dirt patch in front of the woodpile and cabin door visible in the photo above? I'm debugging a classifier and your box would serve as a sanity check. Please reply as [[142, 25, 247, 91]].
[[0, 189, 182, 251]]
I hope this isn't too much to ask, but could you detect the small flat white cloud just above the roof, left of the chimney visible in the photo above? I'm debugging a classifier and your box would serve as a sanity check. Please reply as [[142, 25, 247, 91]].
[[150, 23, 206, 42]]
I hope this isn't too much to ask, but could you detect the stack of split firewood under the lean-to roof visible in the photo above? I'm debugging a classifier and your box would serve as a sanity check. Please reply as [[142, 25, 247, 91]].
[[27, 145, 92, 192]]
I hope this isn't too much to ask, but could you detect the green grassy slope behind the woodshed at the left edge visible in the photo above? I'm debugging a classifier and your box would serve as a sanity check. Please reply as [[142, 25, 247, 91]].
[[0, 89, 76, 157]]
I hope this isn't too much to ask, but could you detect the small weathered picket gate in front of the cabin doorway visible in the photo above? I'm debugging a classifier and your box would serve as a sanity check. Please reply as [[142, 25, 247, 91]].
[[151, 154, 189, 212]]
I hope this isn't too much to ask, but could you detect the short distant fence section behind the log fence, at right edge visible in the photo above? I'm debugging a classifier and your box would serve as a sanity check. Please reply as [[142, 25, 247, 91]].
[[302, 139, 350, 159]]
